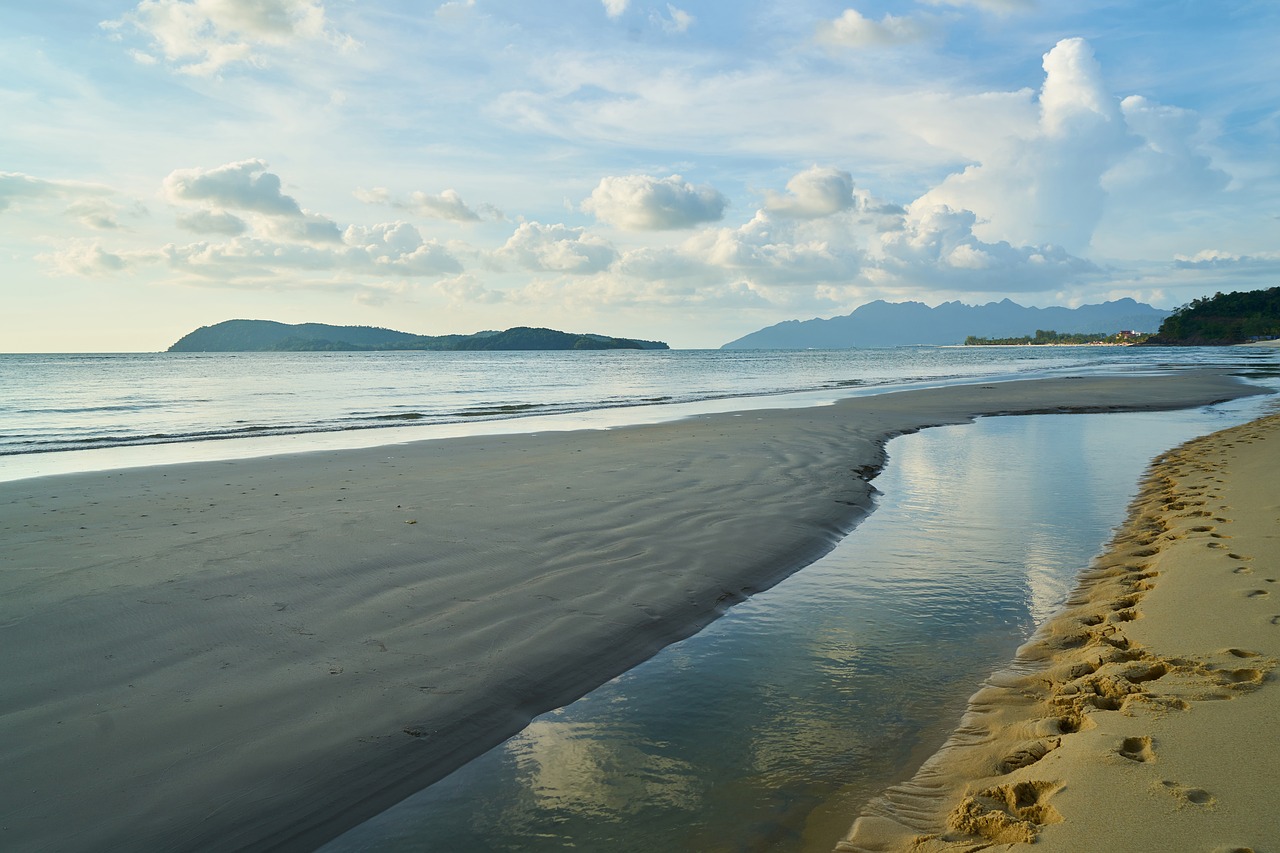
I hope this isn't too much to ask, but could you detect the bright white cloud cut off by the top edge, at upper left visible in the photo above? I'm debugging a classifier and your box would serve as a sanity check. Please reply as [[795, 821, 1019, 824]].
[[101, 0, 355, 76]]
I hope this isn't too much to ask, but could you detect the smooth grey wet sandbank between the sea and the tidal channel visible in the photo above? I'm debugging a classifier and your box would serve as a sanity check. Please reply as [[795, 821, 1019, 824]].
[[0, 371, 1267, 850]]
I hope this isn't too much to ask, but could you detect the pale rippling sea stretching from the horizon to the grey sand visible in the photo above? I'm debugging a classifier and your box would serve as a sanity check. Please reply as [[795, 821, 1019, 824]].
[[0, 347, 1275, 475]]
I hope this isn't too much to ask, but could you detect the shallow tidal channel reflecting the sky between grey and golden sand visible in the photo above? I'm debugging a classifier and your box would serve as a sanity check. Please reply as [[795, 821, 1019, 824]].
[[325, 389, 1280, 853]]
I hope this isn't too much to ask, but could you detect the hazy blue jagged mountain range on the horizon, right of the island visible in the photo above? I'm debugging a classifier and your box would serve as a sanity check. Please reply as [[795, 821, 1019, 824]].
[[721, 298, 1170, 350]]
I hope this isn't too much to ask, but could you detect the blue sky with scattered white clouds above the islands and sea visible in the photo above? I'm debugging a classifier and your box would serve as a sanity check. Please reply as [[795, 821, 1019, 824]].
[[0, 0, 1280, 352]]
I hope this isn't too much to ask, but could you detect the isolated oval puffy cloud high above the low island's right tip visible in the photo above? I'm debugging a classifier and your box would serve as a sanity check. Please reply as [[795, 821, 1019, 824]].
[[582, 174, 728, 231]]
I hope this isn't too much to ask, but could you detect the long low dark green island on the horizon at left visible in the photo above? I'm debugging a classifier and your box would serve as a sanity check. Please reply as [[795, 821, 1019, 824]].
[[169, 320, 668, 352]]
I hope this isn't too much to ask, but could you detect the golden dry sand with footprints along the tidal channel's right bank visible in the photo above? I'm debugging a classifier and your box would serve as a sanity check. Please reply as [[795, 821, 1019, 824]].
[[837, 415, 1280, 853]]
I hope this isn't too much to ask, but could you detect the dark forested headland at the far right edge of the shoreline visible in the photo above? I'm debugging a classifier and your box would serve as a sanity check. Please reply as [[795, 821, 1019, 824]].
[[1146, 281, 1280, 347]]
